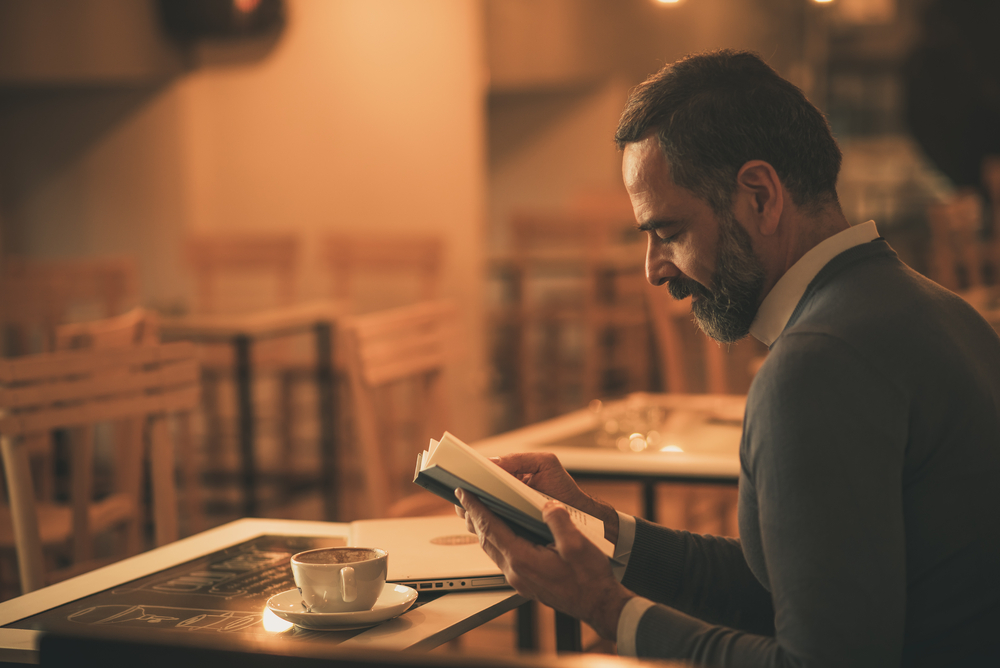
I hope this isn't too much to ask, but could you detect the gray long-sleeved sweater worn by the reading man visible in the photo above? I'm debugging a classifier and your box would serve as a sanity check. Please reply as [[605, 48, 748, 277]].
[[623, 240, 1000, 667]]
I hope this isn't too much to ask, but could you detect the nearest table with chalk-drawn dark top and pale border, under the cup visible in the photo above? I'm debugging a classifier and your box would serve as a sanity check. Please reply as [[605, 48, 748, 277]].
[[0, 519, 525, 663]]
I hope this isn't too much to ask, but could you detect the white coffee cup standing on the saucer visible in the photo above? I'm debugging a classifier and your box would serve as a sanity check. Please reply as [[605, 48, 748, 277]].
[[292, 547, 389, 612]]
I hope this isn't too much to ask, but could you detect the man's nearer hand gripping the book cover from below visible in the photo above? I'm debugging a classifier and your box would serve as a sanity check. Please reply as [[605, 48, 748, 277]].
[[455, 488, 634, 640]]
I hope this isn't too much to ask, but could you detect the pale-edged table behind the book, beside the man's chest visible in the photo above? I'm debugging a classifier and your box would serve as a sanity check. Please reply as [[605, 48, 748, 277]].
[[473, 392, 746, 521]]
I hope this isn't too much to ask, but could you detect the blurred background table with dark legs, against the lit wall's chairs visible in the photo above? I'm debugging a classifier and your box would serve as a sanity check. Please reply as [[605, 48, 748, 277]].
[[160, 300, 349, 520]]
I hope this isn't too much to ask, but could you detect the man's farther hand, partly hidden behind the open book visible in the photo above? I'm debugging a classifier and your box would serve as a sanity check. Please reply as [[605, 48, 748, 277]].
[[455, 452, 618, 545]]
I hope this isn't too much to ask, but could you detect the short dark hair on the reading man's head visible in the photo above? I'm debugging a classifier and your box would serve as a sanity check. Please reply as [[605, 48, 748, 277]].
[[615, 49, 841, 212]]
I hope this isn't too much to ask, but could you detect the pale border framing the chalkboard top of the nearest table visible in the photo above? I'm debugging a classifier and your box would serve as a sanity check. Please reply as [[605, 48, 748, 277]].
[[0, 519, 525, 663]]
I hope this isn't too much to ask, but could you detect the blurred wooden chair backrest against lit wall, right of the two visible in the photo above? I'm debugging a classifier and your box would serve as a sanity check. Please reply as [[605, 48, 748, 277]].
[[323, 234, 444, 313]]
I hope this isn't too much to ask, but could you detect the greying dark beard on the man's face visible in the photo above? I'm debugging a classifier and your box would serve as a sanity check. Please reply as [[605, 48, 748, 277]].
[[667, 213, 764, 343]]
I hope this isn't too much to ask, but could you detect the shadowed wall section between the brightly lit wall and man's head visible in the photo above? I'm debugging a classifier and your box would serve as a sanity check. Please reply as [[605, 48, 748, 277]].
[[486, 0, 807, 247]]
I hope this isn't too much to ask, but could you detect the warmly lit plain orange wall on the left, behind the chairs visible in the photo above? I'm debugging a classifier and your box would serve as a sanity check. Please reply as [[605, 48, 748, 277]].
[[0, 0, 485, 439]]
